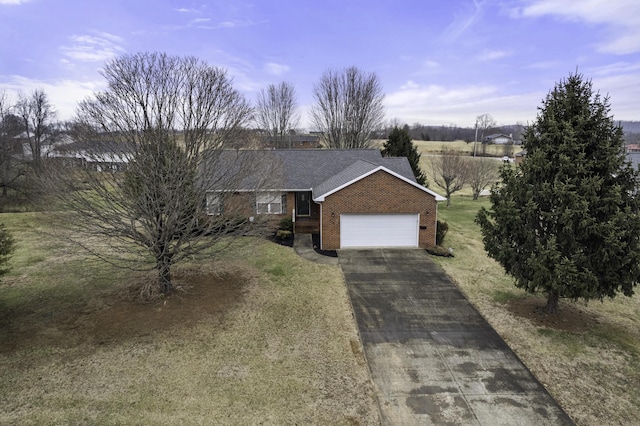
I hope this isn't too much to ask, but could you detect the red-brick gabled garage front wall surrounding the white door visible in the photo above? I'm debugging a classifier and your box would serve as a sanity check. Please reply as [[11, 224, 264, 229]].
[[322, 170, 438, 250]]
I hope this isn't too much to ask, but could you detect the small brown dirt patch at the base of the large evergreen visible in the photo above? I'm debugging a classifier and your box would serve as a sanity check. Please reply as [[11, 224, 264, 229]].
[[507, 297, 599, 333]]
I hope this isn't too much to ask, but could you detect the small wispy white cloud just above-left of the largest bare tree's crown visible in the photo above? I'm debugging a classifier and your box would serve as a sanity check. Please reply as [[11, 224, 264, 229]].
[[60, 33, 125, 62]]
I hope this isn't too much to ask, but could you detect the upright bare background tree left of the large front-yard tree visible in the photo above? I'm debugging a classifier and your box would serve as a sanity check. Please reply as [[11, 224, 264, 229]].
[[16, 89, 56, 174]]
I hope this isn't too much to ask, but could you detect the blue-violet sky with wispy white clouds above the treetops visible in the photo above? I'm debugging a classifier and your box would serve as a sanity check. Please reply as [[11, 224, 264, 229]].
[[0, 0, 640, 126]]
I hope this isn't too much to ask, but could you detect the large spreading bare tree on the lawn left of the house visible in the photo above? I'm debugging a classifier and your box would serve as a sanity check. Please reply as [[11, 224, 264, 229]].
[[46, 53, 266, 293]]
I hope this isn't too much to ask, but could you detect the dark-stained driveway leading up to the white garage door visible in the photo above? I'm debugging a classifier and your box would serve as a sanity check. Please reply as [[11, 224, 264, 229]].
[[338, 249, 573, 426]]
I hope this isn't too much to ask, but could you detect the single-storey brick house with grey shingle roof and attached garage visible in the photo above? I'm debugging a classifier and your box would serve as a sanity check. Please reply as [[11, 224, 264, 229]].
[[207, 149, 445, 250]]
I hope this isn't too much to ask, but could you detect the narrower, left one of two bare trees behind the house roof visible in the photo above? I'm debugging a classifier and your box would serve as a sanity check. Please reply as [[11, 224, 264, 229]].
[[256, 81, 300, 148]]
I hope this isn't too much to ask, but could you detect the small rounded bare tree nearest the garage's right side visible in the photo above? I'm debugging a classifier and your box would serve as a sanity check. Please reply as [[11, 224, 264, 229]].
[[431, 145, 470, 207]]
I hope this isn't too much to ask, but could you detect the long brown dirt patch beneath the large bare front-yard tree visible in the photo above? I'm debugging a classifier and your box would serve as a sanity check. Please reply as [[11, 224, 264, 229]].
[[0, 271, 247, 353]]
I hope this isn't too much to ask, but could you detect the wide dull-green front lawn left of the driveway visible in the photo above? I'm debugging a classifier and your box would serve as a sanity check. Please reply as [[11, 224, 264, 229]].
[[0, 213, 378, 425]]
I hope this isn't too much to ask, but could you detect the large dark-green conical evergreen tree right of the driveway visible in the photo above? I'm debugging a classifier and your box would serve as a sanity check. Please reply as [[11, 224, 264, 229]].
[[476, 74, 640, 313]]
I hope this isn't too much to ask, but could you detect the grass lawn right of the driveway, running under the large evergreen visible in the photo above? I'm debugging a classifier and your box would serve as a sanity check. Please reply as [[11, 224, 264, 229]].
[[434, 192, 640, 425]]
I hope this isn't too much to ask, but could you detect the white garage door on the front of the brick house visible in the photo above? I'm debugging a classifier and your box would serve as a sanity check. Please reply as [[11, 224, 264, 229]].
[[340, 214, 419, 248]]
